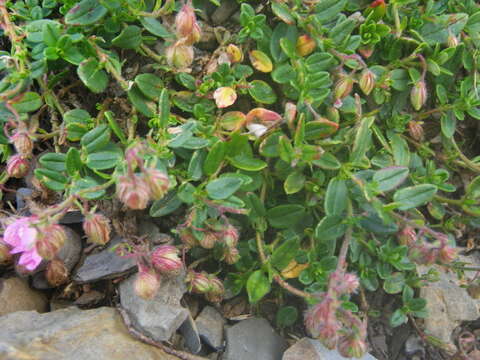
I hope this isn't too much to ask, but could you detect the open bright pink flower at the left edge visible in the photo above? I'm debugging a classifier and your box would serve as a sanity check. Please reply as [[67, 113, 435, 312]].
[[3, 217, 42, 271]]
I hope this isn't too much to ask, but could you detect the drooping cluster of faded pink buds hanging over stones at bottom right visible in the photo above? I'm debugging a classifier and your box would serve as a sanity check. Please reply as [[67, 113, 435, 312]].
[[305, 270, 367, 358]]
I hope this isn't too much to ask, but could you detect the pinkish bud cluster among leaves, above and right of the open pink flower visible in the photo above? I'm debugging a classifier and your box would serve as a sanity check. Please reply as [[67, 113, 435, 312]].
[[117, 143, 170, 210]]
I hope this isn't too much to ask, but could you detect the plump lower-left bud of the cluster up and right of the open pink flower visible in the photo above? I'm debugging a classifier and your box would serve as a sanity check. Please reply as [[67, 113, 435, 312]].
[[117, 175, 150, 210]]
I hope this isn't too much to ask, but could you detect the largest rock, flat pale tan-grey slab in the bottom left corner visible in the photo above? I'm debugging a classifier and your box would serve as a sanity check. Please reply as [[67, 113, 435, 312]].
[[0, 307, 178, 360]]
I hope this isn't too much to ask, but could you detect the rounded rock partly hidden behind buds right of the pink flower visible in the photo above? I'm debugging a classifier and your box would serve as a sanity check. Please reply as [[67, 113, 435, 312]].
[[32, 226, 82, 290]]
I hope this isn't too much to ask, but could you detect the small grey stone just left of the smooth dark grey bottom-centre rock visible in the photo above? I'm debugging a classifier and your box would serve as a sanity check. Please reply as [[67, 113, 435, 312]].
[[195, 306, 225, 350]]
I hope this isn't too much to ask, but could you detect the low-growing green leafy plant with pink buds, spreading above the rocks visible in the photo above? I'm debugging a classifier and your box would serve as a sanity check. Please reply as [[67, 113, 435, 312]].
[[0, 0, 480, 357]]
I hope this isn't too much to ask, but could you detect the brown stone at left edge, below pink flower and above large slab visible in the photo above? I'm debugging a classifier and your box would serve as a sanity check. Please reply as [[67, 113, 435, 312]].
[[0, 277, 48, 316]]
